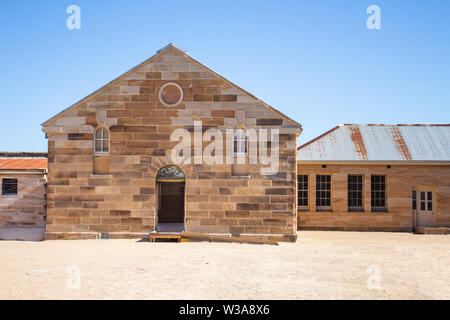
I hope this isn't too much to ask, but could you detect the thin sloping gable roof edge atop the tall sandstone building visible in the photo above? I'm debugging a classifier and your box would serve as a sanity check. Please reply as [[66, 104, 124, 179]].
[[41, 43, 302, 130]]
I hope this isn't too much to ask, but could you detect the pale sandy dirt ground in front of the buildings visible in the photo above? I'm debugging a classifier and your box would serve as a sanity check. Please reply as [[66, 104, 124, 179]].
[[0, 232, 450, 299]]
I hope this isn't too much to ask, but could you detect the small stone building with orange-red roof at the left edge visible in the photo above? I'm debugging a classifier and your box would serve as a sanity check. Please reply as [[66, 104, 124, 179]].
[[0, 152, 47, 230]]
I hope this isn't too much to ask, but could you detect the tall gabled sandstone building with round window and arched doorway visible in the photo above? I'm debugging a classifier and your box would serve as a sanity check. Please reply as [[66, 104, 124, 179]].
[[43, 45, 301, 241]]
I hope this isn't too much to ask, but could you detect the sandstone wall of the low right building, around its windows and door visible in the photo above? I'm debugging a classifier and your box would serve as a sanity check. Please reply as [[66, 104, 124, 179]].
[[297, 162, 450, 231]]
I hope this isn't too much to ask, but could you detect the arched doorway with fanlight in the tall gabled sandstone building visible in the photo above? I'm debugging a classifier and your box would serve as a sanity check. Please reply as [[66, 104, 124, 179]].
[[156, 165, 186, 232]]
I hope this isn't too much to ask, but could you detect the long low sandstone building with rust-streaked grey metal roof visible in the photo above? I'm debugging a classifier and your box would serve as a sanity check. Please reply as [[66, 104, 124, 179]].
[[297, 124, 450, 232]]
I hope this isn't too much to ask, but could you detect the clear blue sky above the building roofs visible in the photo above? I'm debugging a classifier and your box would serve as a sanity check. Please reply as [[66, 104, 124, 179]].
[[0, 0, 450, 151]]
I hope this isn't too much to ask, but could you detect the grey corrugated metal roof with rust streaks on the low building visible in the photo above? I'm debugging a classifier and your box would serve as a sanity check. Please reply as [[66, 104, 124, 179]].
[[297, 124, 450, 161]]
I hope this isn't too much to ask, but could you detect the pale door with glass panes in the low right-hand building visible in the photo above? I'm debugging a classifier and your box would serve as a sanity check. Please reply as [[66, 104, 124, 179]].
[[413, 189, 436, 227]]
